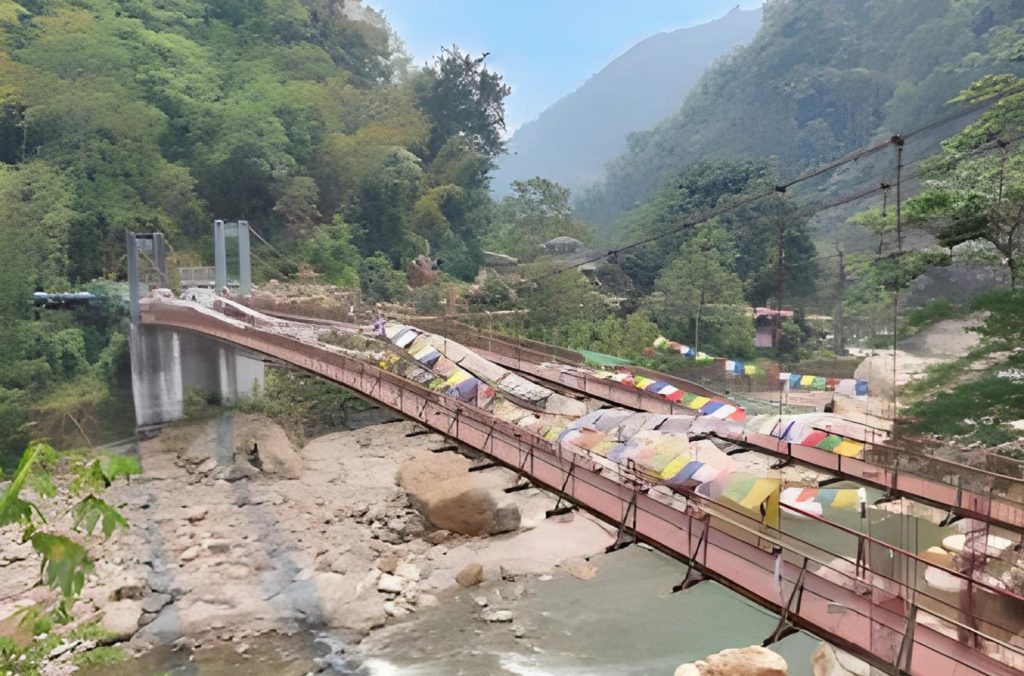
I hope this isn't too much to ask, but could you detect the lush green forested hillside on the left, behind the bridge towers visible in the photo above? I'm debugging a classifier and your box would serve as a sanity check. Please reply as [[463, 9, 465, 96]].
[[0, 0, 509, 462]]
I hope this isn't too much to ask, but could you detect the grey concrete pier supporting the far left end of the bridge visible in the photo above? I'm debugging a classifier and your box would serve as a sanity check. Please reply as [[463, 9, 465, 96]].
[[131, 326, 263, 427]]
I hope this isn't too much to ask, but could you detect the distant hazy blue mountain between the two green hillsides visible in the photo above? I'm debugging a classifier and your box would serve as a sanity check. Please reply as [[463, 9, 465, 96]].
[[495, 8, 761, 194]]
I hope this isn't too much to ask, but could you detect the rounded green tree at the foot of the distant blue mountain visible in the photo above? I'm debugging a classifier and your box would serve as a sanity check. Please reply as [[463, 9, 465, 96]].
[[485, 176, 591, 257]]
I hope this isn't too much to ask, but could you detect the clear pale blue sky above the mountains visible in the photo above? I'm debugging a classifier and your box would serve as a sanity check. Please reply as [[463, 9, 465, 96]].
[[366, 0, 761, 132]]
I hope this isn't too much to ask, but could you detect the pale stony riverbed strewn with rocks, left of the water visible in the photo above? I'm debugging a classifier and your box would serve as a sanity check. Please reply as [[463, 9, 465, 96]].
[[0, 414, 613, 671]]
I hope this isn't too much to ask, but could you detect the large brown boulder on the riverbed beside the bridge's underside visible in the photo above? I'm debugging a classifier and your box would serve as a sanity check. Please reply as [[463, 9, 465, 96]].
[[398, 452, 520, 536]]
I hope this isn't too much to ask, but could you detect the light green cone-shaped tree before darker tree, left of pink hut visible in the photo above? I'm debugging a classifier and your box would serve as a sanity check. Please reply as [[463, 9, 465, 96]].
[[649, 221, 754, 355]]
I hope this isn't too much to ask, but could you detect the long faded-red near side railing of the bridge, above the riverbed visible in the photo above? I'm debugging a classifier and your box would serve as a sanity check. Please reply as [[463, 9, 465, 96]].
[[142, 303, 1024, 673]]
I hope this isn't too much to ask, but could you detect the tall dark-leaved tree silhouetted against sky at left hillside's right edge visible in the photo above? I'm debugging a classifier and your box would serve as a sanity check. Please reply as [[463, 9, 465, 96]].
[[413, 45, 512, 160]]
